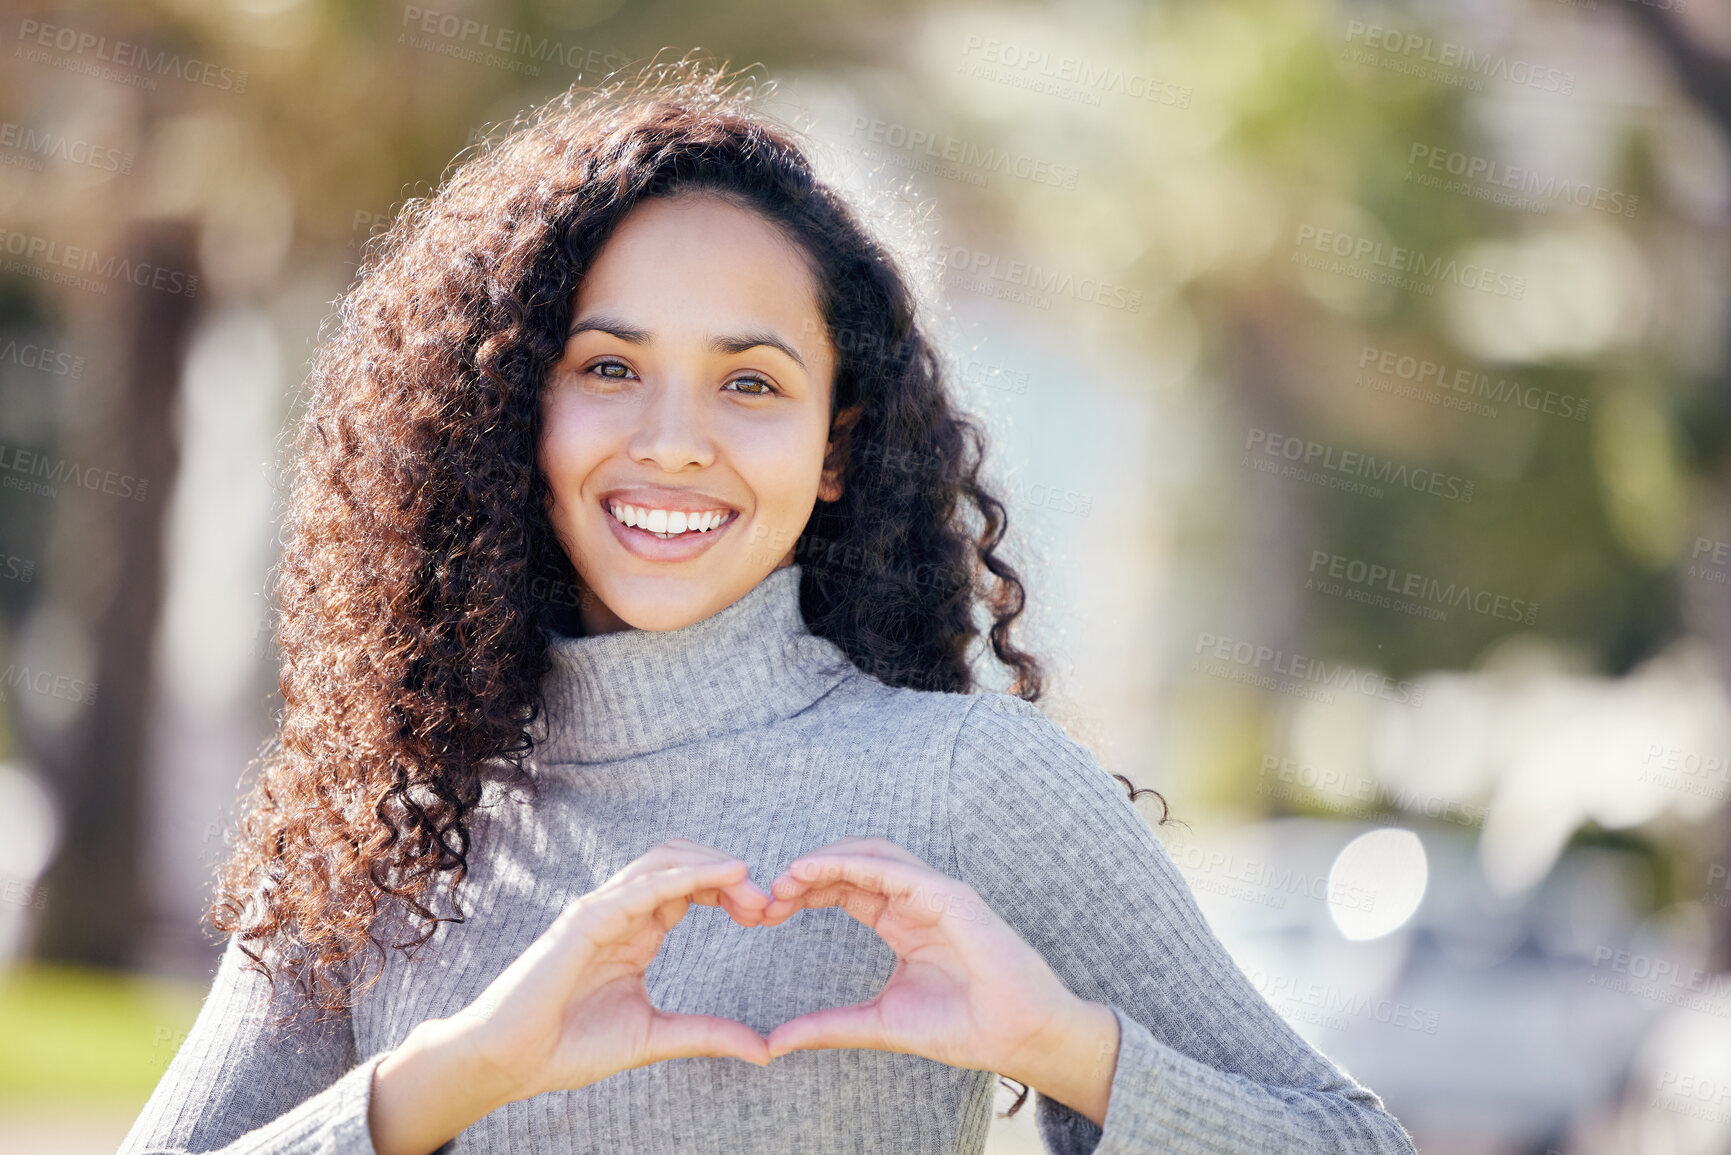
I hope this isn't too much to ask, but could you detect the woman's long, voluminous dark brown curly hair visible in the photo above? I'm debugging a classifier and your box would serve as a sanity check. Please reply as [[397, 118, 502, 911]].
[[211, 61, 1163, 1107]]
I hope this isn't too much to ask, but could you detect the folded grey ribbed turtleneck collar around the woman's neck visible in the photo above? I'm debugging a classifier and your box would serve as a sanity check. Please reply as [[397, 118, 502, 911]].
[[535, 565, 853, 764]]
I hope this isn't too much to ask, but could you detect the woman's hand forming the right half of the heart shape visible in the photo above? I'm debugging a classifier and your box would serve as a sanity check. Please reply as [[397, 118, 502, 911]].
[[762, 836, 1116, 1082]]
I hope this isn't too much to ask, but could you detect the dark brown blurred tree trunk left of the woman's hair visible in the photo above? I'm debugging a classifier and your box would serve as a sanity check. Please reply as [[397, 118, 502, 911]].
[[36, 222, 197, 966]]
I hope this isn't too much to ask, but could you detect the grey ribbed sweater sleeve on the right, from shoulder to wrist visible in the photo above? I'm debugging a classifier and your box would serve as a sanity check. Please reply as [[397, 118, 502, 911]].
[[947, 693, 1414, 1155]]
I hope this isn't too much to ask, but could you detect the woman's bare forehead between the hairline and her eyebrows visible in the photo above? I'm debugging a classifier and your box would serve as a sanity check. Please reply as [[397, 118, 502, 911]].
[[575, 194, 827, 339]]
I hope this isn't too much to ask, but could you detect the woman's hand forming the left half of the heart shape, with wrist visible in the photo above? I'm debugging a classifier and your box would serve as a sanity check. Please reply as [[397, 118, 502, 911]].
[[369, 838, 770, 1155]]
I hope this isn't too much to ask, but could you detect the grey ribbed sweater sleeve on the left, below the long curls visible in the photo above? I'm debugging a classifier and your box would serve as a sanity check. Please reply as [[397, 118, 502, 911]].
[[119, 939, 388, 1155]]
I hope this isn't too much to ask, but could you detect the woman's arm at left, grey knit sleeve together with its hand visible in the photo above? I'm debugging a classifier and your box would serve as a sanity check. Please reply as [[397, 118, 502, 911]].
[[131, 838, 782, 1155]]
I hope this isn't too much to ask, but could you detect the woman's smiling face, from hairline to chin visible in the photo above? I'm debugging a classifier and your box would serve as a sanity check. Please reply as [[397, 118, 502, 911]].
[[540, 196, 841, 634]]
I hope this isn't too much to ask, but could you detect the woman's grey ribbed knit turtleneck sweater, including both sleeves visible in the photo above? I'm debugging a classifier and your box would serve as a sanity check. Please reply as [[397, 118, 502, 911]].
[[121, 566, 1412, 1155]]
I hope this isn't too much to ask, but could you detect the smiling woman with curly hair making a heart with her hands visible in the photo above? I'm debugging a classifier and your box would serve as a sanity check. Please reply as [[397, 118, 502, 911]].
[[123, 68, 1412, 1155]]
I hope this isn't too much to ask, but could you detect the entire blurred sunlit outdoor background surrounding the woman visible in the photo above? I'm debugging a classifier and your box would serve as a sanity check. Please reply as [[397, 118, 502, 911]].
[[0, 0, 1731, 1153]]
